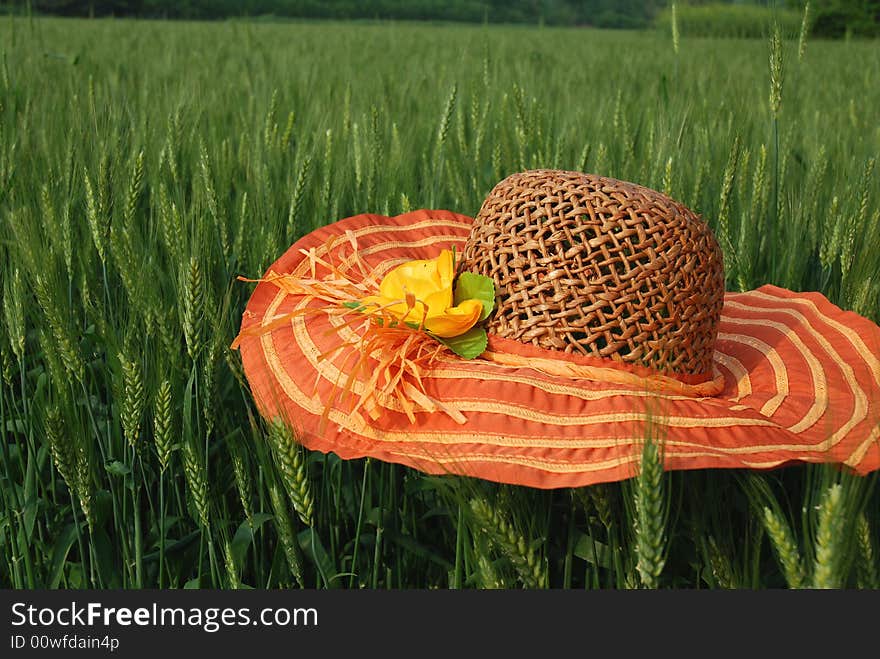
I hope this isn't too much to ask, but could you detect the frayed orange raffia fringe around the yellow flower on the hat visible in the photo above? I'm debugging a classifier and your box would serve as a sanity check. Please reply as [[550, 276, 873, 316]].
[[231, 231, 466, 424]]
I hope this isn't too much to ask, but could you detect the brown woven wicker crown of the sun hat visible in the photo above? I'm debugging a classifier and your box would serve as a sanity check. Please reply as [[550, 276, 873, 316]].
[[462, 170, 724, 375]]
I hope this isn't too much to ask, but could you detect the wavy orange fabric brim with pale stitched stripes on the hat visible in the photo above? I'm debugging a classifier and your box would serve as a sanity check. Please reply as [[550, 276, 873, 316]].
[[240, 210, 880, 488]]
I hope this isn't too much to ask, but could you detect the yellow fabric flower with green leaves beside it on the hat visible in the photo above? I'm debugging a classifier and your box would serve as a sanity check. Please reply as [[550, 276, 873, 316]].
[[361, 249, 483, 338]]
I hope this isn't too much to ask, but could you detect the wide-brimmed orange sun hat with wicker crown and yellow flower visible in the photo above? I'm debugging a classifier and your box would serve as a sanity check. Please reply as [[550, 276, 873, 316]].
[[234, 170, 880, 488]]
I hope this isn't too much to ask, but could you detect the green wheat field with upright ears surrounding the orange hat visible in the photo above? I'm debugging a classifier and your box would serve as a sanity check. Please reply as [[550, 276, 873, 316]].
[[0, 17, 880, 588]]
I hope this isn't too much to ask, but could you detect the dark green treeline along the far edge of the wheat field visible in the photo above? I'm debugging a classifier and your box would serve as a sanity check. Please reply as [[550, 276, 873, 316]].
[[6, 0, 880, 37]]
